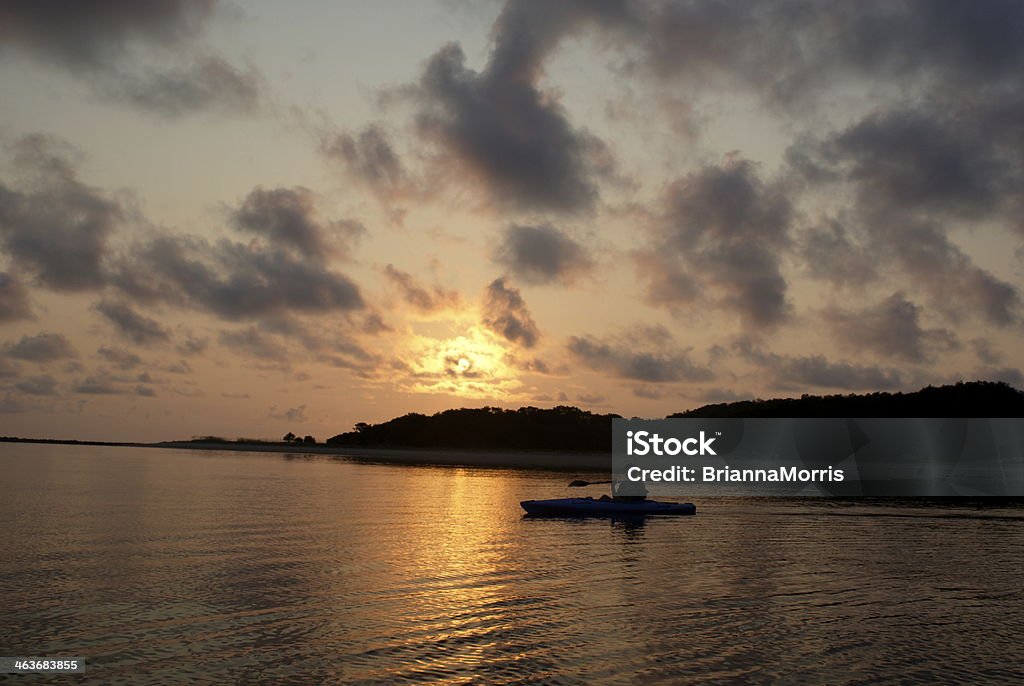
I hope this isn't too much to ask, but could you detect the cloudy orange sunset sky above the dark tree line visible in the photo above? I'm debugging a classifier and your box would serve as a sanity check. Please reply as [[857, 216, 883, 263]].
[[0, 0, 1024, 440]]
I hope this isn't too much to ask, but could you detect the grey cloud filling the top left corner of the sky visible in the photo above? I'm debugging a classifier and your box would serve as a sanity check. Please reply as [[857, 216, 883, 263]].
[[0, 0, 263, 117]]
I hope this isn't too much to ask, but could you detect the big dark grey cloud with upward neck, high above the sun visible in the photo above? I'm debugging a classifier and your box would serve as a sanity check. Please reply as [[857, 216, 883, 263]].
[[417, 28, 608, 212]]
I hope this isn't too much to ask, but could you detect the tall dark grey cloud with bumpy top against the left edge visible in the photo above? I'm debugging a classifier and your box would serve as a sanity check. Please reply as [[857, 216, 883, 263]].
[[0, 134, 124, 291]]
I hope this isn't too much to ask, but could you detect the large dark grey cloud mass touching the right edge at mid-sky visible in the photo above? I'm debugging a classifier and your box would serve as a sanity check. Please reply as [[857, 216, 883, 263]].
[[791, 105, 1024, 326]]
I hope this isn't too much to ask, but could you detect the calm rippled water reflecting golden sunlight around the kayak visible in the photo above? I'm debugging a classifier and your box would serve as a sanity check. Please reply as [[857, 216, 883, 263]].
[[0, 443, 1024, 684]]
